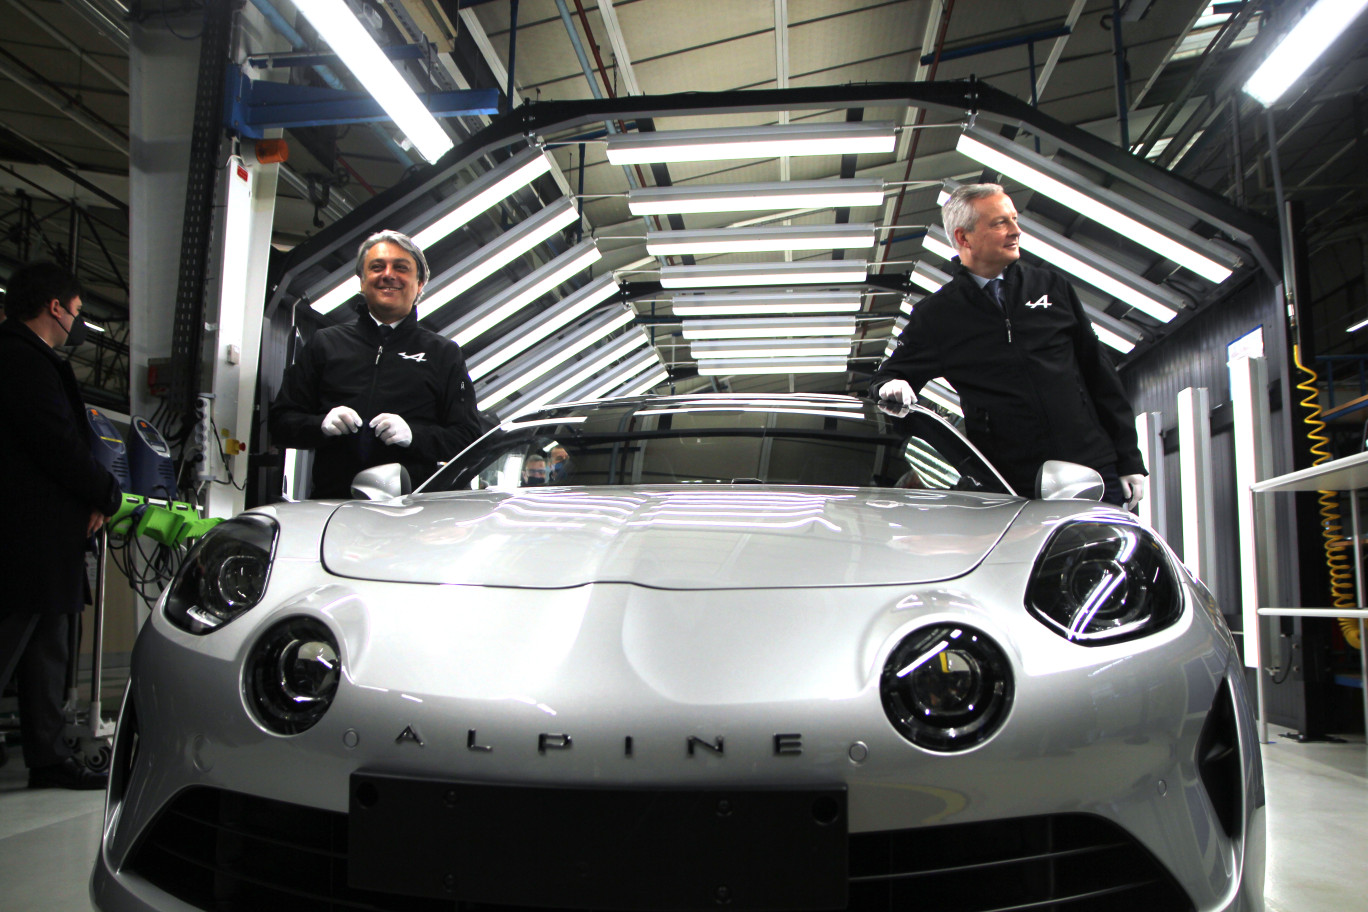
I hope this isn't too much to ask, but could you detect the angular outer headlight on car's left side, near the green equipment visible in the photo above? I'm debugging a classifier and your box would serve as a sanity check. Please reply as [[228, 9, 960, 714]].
[[166, 513, 279, 634]]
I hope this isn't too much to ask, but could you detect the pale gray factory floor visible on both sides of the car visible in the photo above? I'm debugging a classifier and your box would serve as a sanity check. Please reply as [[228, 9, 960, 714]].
[[0, 729, 1368, 912]]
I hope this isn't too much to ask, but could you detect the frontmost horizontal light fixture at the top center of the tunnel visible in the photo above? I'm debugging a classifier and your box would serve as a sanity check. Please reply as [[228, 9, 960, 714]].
[[607, 120, 897, 164]]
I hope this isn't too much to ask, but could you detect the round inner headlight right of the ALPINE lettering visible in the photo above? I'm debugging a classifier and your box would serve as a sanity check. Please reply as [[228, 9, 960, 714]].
[[880, 623, 1012, 751]]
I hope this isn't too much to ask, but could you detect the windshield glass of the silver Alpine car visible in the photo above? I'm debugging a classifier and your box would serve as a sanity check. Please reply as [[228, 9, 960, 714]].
[[423, 397, 1007, 492]]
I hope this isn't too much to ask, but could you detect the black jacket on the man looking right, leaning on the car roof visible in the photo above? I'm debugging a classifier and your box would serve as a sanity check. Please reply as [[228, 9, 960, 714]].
[[870, 258, 1145, 496]]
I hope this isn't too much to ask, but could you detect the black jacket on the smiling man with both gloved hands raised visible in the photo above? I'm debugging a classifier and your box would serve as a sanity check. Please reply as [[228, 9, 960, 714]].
[[268, 305, 486, 498]]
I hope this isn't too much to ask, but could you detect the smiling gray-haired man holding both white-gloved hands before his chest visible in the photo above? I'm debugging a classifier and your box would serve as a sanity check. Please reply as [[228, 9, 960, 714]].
[[268, 231, 484, 498]]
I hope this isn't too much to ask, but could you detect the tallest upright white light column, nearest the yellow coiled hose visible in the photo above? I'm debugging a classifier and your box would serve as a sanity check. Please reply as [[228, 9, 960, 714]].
[[1227, 358, 1278, 669]]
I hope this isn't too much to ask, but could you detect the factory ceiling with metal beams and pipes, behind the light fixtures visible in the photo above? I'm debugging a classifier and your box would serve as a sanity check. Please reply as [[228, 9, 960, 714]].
[[0, 0, 1368, 399]]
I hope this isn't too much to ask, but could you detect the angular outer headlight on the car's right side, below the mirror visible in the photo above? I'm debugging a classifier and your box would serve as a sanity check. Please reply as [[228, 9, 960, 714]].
[[1026, 522, 1183, 645]]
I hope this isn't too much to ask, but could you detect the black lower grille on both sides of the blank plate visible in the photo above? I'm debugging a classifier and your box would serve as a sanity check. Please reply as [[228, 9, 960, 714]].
[[127, 788, 1193, 912]]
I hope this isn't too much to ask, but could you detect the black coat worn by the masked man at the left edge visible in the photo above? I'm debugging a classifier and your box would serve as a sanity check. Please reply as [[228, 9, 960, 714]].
[[0, 319, 120, 615]]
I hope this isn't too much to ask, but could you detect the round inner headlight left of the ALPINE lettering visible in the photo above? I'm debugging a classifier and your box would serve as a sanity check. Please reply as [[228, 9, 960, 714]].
[[242, 617, 342, 734]]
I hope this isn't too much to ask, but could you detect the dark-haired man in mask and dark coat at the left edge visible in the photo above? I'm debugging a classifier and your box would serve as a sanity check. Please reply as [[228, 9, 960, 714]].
[[0, 263, 120, 789]]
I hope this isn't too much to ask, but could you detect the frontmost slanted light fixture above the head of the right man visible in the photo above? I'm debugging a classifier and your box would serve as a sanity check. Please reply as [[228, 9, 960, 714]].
[[956, 127, 1239, 283]]
